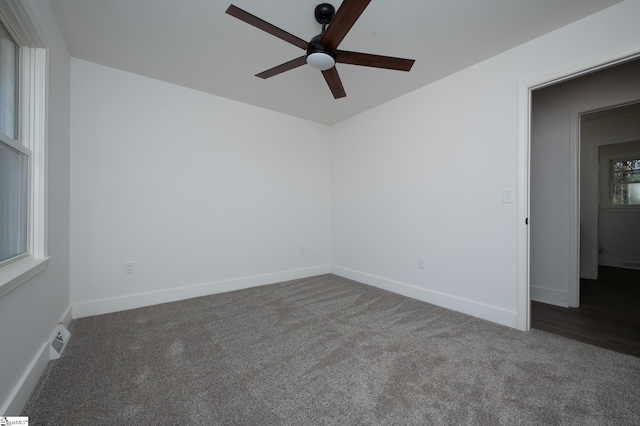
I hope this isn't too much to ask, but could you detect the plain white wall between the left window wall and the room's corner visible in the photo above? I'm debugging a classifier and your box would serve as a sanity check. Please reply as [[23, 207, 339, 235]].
[[71, 59, 331, 317]]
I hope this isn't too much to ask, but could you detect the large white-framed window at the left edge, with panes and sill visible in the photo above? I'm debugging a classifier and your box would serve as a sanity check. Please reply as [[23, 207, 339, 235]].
[[0, 0, 48, 297]]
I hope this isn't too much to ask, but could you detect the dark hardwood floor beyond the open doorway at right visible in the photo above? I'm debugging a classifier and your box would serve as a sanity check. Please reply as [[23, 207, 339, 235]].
[[531, 266, 640, 357]]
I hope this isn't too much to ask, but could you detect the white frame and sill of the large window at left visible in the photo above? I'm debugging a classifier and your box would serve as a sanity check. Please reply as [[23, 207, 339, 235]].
[[0, 0, 49, 297]]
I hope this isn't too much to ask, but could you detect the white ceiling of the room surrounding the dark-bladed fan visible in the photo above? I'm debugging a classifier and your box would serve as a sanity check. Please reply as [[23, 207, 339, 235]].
[[51, 0, 621, 124]]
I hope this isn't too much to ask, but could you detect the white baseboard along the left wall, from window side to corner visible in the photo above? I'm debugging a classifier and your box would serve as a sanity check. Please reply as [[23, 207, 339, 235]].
[[72, 265, 331, 318]]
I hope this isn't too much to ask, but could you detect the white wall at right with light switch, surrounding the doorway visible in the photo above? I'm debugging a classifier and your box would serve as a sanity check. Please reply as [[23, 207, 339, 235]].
[[331, 1, 640, 326]]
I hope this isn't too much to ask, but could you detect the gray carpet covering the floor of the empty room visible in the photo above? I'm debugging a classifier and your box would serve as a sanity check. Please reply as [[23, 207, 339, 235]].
[[23, 275, 640, 425]]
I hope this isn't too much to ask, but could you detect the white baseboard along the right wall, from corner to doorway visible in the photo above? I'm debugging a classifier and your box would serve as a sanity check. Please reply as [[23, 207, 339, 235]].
[[331, 266, 517, 328]]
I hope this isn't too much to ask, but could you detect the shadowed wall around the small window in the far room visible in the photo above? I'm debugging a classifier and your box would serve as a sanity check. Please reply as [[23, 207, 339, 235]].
[[596, 140, 640, 269]]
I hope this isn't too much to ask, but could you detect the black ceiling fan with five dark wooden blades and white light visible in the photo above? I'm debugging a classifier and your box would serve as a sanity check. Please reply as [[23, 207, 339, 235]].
[[226, 0, 415, 99]]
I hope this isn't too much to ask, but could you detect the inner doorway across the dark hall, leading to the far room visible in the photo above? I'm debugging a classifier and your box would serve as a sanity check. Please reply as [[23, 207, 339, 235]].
[[579, 104, 640, 280]]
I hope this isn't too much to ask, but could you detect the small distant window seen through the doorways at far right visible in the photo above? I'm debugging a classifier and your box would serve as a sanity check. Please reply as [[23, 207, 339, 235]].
[[610, 157, 640, 207]]
